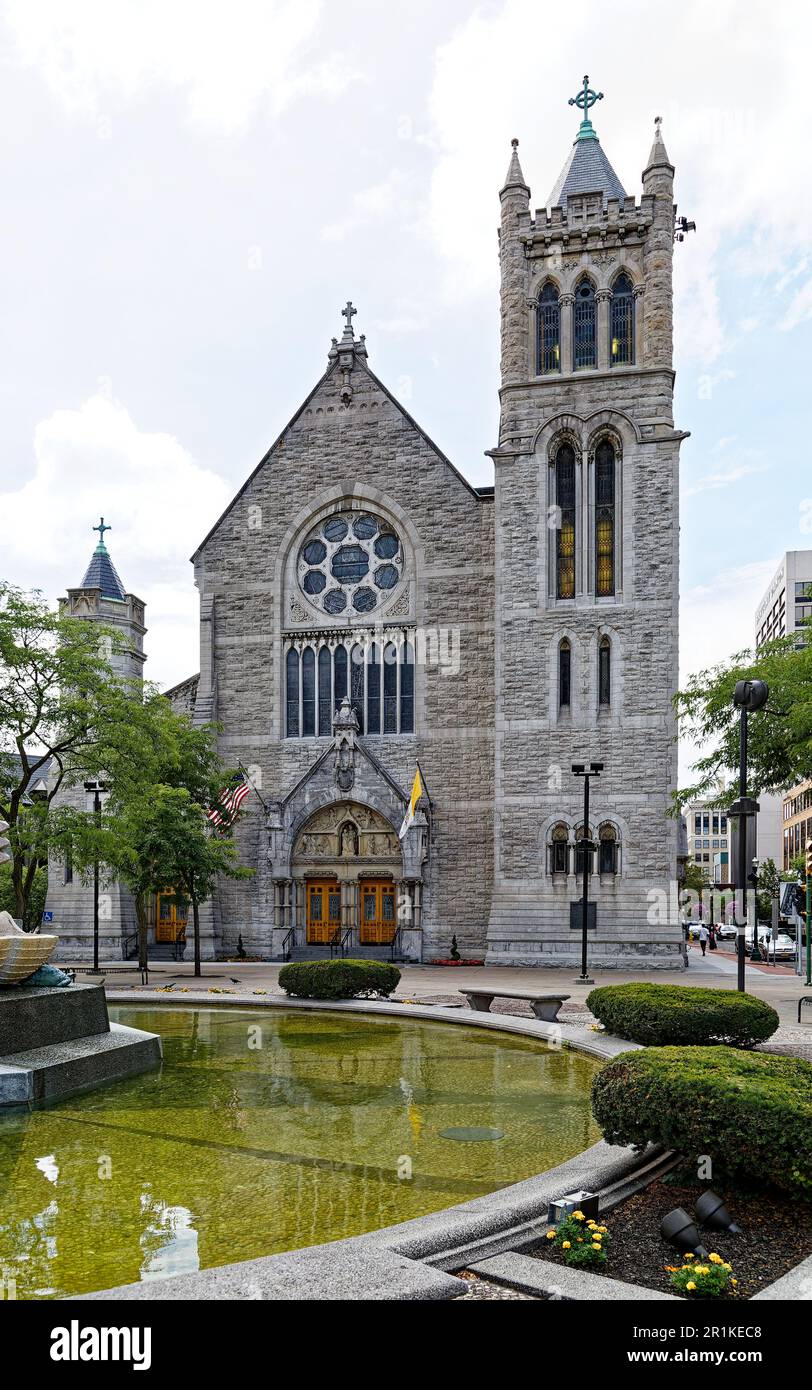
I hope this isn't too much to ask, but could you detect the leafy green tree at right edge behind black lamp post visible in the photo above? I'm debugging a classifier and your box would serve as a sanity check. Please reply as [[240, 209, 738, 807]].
[[674, 620, 812, 806]]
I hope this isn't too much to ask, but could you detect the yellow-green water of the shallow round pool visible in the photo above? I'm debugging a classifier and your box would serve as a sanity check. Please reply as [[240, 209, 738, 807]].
[[0, 1008, 599, 1298]]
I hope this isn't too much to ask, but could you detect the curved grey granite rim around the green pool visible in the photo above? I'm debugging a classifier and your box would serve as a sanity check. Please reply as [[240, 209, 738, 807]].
[[82, 988, 651, 1302]]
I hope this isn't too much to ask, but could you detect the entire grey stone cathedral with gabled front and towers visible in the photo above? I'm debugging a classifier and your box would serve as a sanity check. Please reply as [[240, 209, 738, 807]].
[[49, 81, 684, 969]]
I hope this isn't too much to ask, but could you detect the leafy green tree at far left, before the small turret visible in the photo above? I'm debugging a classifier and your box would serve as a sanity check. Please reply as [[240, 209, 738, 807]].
[[0, 582, 175, 922]]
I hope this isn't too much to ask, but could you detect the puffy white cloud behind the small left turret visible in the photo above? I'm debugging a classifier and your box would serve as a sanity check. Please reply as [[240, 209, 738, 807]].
[[0, 395, 231, 685]]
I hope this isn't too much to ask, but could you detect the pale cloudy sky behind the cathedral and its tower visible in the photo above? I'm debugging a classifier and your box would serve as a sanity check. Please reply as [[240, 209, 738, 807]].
[[0, 0, 812, 783]]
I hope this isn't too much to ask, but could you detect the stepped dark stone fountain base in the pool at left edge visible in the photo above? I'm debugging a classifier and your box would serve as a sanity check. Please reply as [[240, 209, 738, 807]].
[[0, 984, 161, 1108]]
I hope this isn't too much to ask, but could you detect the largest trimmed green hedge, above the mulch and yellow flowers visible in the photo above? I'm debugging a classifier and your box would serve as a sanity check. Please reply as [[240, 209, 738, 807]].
[[592, 1047, 812, 1194]]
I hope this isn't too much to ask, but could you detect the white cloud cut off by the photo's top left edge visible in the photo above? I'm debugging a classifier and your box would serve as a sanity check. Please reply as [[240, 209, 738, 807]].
[[4, 0, 357, 133]]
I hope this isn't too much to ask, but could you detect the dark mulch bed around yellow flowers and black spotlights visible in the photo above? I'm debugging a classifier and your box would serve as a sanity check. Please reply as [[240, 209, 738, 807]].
[[527, 1172, 812, 1301]]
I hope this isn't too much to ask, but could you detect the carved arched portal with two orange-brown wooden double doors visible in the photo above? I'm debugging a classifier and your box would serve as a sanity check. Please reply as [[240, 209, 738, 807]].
[[292, 801, 413, 951]]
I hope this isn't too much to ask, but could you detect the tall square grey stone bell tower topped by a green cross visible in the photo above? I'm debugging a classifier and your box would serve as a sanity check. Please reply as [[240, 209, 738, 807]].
[[488, 78, 684, 969]]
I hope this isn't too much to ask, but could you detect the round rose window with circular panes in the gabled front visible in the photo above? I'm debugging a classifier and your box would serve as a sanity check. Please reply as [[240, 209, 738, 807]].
[[298, 512, 403, 617]]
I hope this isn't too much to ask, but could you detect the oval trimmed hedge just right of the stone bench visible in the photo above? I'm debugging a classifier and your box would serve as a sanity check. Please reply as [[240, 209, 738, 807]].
[[587, 983, 779, 1047]]
